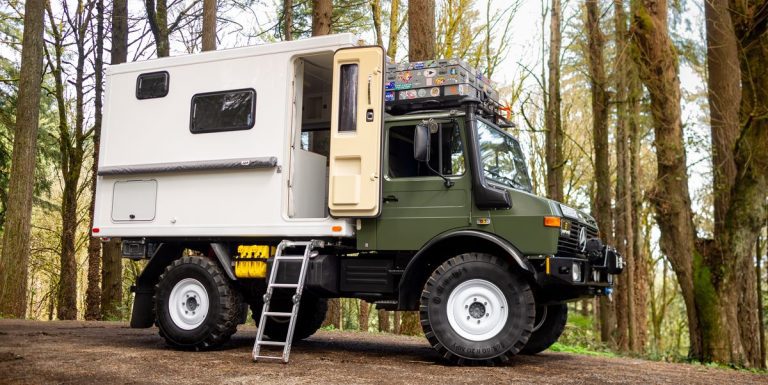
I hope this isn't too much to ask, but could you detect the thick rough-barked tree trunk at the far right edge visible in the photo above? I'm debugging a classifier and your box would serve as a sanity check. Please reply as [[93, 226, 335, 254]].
[[716, 1, 768, 368]]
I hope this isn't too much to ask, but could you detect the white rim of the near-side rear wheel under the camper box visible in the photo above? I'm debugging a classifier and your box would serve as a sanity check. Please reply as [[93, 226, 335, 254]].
[[168, 278, 209, 330]]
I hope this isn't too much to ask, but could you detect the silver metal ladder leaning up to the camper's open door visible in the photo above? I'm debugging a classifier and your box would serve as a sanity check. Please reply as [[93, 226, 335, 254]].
[[253, 240, 322, 364]]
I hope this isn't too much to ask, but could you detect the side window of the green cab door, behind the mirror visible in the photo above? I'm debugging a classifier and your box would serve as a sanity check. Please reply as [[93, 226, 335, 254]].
[[388, 123, 465, 178]]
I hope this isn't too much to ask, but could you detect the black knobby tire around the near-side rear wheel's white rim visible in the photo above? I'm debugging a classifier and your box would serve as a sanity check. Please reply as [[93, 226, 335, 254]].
[[155, 256, 244, 350]]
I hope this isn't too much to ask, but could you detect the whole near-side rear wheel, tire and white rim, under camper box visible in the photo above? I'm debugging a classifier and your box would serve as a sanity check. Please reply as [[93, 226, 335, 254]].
[[155, 256, 243, 349]]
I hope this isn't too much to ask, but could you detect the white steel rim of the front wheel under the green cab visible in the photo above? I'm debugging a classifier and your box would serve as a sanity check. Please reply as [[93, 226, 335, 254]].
[[446, 279, 509, 341]]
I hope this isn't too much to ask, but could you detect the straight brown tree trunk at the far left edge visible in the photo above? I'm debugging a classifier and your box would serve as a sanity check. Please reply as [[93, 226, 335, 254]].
[[0, 0, 45, 318]]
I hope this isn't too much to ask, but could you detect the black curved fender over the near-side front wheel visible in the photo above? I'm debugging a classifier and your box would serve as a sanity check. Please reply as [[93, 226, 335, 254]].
[[398, 229, 536, 310]]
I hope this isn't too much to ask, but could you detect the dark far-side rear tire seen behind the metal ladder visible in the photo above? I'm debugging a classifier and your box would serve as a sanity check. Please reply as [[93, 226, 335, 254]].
[[251, 292, 328, 341]]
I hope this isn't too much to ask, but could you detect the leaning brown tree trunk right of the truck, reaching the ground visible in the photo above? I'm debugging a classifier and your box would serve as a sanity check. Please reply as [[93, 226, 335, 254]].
[[632, 0, 708, 361]]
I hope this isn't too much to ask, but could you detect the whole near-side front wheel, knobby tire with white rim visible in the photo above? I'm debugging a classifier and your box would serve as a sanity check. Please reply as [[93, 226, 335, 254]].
[[419, 253, 535, 365]]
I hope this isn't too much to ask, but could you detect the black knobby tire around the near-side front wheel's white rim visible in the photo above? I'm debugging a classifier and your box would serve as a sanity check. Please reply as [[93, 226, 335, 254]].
[[419, 253, 535, 365]]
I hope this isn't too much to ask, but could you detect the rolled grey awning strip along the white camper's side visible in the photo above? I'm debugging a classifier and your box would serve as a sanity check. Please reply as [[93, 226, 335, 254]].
[[98, 156, 277, 176]]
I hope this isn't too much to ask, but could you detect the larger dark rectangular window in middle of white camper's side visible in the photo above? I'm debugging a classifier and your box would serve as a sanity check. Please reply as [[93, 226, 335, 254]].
[[189, 89, 256, 134]]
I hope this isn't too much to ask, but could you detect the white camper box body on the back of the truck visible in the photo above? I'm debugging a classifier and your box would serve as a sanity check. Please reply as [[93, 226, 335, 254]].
[[94, 34, 355, 237]]
